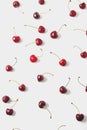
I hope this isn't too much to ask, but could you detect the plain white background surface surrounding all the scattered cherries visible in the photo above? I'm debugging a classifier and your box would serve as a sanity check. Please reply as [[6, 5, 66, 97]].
[[0, 0, 87, 130]]
